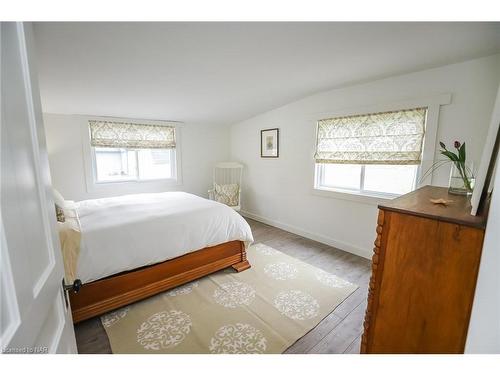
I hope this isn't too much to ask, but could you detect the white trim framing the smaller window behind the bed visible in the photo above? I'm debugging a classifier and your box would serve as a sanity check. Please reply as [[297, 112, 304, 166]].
[[81, 116, 183, 194]]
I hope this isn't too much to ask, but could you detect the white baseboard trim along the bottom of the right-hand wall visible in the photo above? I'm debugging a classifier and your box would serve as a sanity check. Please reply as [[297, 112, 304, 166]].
[[240, 210, 372, 259]]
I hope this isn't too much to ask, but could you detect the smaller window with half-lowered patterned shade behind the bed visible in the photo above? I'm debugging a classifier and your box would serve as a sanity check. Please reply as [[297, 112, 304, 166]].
[[89, 121, 176, 183]]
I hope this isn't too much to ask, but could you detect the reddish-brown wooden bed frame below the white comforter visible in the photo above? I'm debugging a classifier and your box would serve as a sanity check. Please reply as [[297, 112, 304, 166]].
[[70, 241, 250, 323]]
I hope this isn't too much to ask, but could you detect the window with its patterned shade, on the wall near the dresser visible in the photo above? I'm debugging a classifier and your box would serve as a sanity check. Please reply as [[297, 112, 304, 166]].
[[315, 108, 427, 196]]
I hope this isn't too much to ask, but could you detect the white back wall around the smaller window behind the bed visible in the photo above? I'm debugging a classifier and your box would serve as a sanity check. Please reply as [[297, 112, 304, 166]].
[[44, 113, 229, 201]]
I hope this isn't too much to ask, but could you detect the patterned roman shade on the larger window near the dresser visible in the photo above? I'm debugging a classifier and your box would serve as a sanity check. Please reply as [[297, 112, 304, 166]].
[[314, 108, 427, 164]]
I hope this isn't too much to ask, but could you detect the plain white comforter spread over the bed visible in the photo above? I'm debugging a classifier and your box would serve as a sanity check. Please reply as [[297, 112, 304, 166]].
[[76, 192, 253, 283]]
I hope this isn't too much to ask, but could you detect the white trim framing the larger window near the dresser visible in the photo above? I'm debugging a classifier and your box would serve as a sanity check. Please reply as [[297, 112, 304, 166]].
[[310, 94, 452, 206]]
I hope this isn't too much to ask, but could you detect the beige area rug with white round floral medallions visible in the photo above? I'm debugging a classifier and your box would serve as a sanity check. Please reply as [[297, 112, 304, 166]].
[[101, 244, 358, 353]]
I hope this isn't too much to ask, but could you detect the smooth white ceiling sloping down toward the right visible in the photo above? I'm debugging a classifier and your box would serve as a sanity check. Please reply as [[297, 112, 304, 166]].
[[35, 23, 500, 124]]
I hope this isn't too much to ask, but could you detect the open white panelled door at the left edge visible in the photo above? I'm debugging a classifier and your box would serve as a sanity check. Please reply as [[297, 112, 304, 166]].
[[0, 23, 76, 353]]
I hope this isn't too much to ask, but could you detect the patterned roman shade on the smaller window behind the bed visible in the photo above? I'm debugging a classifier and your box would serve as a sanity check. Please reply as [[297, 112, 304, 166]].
[[89, 120, 175, 148]]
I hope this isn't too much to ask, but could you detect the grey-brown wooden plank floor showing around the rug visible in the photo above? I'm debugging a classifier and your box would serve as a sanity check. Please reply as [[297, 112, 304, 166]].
[[75, 219, 371, 354]]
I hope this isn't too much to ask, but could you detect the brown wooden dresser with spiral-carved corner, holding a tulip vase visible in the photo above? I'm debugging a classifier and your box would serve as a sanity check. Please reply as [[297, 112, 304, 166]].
[[361, 186, 486, 353]]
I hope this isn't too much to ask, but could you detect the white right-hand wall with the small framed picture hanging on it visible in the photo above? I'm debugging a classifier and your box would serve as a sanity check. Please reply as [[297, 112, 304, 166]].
[[231, 55, 500, 257]]
